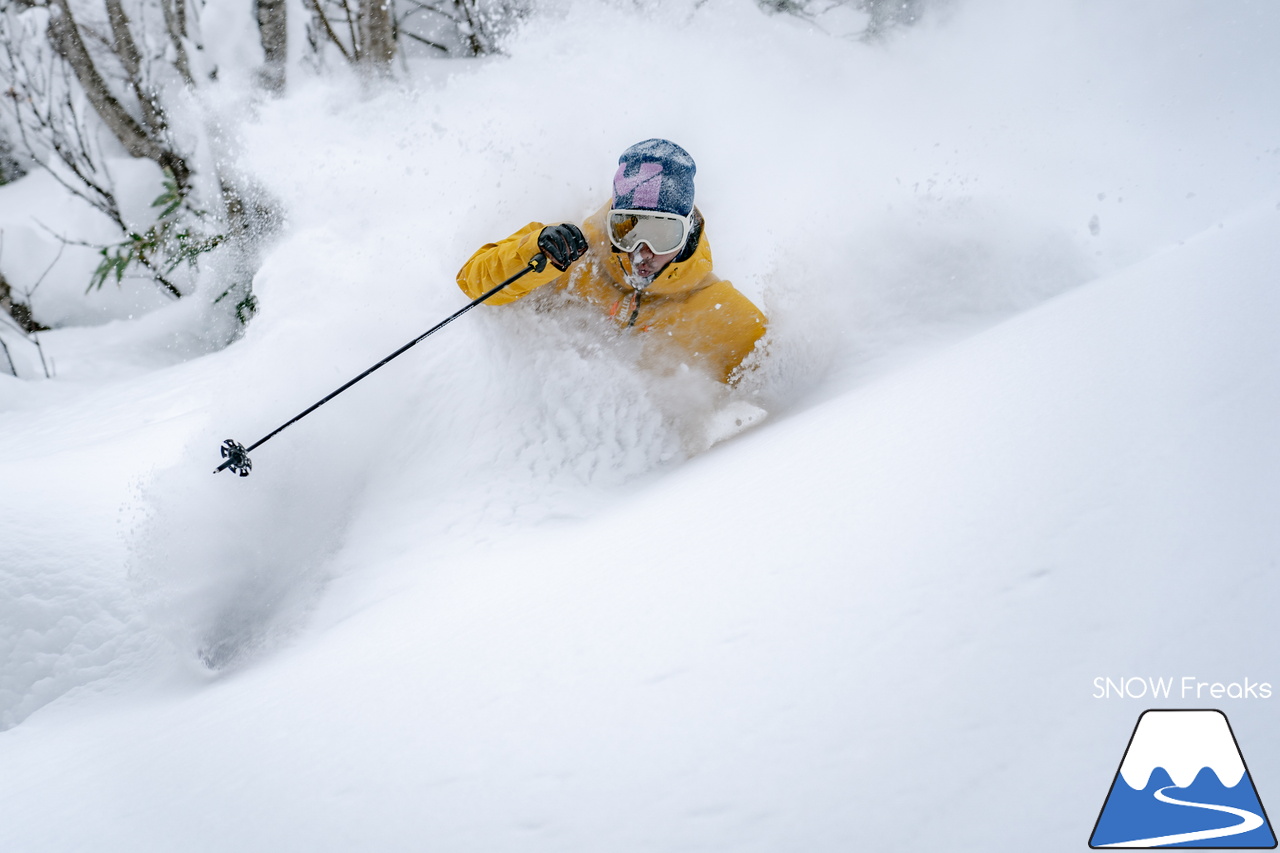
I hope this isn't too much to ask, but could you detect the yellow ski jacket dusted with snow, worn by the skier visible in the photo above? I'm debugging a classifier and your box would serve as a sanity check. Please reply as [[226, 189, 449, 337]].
[[458, 204, 765, 382]]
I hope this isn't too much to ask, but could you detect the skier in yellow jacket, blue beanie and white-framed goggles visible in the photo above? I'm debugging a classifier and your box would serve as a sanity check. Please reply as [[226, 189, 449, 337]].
[[458, 140, 765, 383]]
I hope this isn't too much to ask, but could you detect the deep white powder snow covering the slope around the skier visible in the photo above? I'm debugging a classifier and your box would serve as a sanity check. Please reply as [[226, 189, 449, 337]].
[[0, 0, 1280, 853]]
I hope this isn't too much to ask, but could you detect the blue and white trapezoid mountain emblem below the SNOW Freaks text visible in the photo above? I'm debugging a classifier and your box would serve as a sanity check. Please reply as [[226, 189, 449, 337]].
[[1089, 711, 1276, 849]]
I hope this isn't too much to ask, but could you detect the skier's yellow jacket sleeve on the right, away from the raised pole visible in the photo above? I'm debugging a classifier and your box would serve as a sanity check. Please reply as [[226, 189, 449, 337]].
[[666, 280, 765, 382]]
